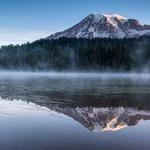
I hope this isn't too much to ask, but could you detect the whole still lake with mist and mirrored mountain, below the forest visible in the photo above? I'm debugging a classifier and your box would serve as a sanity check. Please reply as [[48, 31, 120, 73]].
[[0, 72, 150, 150]]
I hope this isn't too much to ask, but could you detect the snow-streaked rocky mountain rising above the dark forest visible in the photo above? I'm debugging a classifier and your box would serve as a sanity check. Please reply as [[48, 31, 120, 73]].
[[46, 14, 150, 39]]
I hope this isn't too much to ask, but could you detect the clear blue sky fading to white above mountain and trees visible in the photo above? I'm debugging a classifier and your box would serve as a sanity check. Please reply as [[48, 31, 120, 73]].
[[0, 0, 150, 45]]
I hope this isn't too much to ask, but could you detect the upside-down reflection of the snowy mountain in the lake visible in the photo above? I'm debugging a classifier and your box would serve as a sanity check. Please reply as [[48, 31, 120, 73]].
[[50, 105, 150, 132]]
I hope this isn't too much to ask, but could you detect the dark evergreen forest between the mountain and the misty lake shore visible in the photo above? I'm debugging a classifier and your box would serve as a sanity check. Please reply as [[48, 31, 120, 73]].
[[0, 36, 150, 71]]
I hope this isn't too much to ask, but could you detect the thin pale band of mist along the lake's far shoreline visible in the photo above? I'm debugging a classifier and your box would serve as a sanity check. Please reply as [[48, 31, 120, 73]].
[[0, 71, 150, 79]]
